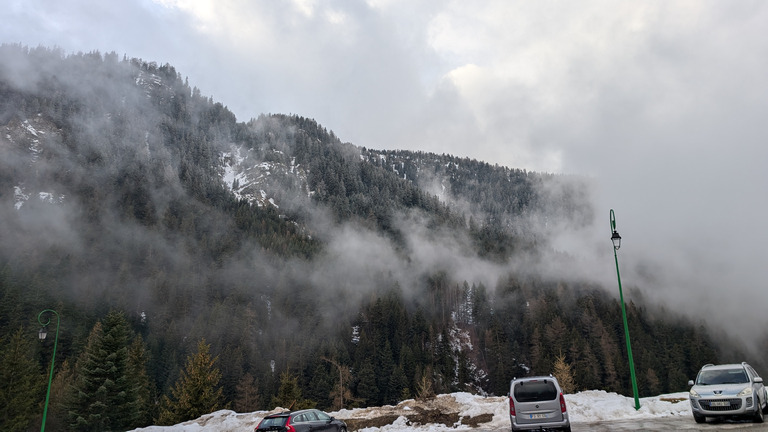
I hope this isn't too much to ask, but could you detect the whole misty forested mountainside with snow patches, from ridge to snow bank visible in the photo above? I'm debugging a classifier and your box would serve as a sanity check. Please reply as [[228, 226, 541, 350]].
[[0, 45, 739, 430]]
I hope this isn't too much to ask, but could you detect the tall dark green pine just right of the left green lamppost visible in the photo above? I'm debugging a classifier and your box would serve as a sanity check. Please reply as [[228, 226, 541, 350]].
[[68, 312, 139, 431]]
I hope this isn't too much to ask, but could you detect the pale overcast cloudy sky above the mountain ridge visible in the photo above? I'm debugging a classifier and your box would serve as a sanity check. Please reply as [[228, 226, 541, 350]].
[[0, 0, 768, 338]]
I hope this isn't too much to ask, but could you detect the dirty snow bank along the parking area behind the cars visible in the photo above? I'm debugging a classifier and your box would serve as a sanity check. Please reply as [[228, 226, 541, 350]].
[[134, 390, 691, 432]]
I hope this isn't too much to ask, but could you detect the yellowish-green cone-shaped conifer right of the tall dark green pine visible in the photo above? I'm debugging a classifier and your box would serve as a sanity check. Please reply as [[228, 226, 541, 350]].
[[157, 339, 224, 425]]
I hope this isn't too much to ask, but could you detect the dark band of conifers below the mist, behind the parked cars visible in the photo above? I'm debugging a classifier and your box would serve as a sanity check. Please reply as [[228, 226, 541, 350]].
[[0, 275, 729, 431]]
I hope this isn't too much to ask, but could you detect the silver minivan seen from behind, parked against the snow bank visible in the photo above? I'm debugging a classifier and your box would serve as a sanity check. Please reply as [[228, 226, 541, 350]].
[[509, 375, 571, 432]]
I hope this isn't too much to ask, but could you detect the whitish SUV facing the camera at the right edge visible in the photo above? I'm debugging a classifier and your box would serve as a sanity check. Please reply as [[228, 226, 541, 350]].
[[688, 363, 768, 423]]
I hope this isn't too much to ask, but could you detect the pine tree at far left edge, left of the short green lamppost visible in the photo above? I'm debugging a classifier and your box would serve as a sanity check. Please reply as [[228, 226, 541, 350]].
[[0, 328, 43, 432]]
